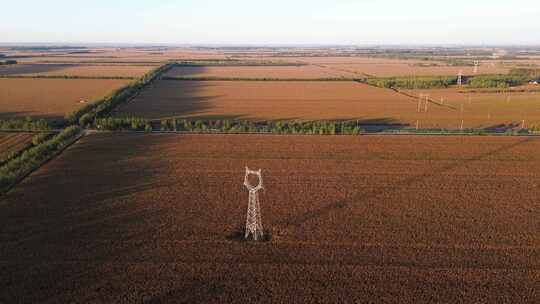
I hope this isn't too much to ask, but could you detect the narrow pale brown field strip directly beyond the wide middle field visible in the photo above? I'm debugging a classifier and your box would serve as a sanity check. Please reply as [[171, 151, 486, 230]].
[[166, 65, 358, 79]]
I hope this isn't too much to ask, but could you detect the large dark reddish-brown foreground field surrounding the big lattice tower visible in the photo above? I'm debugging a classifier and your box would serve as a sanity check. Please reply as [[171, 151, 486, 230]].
[[0, 134, 540, 303]]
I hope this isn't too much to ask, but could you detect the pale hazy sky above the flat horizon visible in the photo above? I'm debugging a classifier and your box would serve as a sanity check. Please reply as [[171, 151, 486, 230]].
[[0, 0, 540, 44]]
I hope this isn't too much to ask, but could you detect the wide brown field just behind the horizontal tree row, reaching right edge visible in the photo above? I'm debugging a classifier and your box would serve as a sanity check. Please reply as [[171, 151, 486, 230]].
[[115, 81, 540, 129]]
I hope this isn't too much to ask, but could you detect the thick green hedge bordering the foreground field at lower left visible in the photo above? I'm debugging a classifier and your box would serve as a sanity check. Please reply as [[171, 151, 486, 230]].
[[0, 126, 81, 193]]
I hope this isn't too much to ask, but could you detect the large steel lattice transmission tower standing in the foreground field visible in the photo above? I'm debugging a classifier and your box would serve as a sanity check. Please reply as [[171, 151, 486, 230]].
[[244, 167, 264, 241]]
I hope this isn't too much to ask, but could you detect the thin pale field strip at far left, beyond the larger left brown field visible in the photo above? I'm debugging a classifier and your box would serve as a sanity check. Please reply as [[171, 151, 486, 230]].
[[0, 64, 155, 77]]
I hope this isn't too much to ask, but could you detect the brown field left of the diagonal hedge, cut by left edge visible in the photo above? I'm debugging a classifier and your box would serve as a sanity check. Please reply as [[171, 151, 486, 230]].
[[0, 79, 130, 119]]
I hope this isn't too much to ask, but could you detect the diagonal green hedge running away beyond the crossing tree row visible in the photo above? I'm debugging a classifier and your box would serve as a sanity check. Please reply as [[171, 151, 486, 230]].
[[66, 64, 174, 125]]
